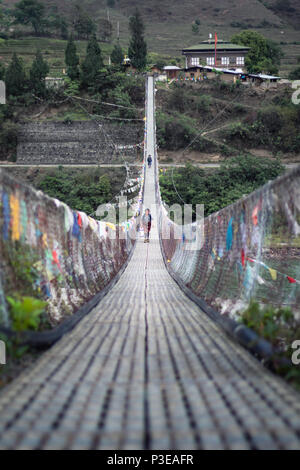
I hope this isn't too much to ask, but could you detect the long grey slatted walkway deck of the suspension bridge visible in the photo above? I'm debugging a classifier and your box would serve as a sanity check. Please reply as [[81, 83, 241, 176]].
[[0, 77, 300, 449]]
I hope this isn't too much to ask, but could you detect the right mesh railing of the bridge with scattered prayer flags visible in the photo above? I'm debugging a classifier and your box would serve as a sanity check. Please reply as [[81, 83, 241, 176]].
[[157, 161, 300, 318]]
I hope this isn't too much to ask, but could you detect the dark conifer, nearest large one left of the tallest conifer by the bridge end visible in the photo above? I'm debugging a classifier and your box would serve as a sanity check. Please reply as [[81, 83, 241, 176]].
[[81, 34, 103, 88]]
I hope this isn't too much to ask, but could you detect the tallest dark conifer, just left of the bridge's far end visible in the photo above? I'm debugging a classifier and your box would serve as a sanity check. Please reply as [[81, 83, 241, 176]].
[[128, 10, 147, 70]]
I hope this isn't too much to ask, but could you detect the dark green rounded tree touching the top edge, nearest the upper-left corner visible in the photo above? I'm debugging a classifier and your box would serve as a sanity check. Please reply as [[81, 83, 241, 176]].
[[13, 0, 45, 36]]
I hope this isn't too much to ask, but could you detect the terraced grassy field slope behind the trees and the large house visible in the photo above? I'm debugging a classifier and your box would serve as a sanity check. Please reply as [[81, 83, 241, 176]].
[[0, 0, 300, 76]]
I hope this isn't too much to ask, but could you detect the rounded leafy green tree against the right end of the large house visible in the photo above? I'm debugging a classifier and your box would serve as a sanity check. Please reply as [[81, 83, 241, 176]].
[[231, 31, 283, 74]]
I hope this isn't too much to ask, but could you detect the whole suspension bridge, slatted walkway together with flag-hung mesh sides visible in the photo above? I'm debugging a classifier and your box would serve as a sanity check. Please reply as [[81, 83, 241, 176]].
[[0, 77, 300, 449]]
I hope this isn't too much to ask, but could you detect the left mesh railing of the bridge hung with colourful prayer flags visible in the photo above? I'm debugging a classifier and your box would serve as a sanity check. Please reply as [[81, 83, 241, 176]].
[[0, 169, 143, 326]]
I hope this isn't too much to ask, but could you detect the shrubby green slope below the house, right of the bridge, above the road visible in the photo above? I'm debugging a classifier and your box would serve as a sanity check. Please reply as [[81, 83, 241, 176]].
[[157, 80, 300, 163]]
